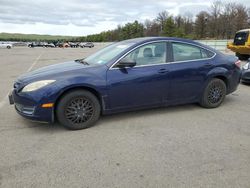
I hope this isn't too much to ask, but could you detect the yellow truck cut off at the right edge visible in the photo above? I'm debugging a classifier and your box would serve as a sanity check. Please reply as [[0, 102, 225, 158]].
[[227, 29, 250, 60]]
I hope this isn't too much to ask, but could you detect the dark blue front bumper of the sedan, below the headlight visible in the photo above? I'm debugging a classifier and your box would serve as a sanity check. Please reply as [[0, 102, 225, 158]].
[[9, 89, 54, 123]]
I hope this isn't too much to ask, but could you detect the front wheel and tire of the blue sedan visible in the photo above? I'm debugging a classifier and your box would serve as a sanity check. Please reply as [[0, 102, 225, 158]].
[[56, 90, 101, 130]]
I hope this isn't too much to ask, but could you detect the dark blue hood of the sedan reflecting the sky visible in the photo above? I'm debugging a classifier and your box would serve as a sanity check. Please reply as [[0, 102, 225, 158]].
[[17, 61, 96, 83]]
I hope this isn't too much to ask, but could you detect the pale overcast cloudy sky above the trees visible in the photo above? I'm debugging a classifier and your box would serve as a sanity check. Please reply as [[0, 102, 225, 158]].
[[0, 0, 250, 36]]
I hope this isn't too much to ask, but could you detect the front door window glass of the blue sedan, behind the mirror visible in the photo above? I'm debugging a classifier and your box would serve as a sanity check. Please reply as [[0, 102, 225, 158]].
[[121, 42, 166, 66]]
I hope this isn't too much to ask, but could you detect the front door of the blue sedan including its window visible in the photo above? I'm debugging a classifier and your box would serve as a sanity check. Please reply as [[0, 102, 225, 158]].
[[107, 42, 169, 109]]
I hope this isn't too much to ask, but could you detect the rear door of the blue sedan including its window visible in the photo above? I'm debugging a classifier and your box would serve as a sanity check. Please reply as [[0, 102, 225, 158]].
[[165, 42, 215, 103]]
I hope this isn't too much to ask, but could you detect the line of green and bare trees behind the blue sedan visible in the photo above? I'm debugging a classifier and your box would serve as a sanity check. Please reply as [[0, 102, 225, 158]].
[[77, 1, 250, 42]]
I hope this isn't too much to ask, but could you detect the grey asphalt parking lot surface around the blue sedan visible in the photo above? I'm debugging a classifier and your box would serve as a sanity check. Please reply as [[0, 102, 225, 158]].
[[0, 47, 250, 188]]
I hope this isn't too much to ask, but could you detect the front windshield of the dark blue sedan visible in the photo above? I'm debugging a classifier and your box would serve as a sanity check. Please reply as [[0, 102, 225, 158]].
[[84, 42, 135, 65]]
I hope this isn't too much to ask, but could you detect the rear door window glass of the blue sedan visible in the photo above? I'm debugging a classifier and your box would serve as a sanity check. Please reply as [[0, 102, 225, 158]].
[[172, 43, 214, 61]]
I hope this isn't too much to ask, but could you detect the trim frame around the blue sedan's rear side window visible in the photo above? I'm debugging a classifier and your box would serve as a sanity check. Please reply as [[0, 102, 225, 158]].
[[169, 40, 217, 63]]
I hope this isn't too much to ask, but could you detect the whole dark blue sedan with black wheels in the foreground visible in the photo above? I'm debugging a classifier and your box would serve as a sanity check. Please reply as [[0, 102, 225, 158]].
[[9, 37, 241, 129]]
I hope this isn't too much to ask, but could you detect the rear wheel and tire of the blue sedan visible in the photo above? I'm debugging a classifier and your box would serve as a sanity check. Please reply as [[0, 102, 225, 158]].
[[200, 78, 227, 108]]
